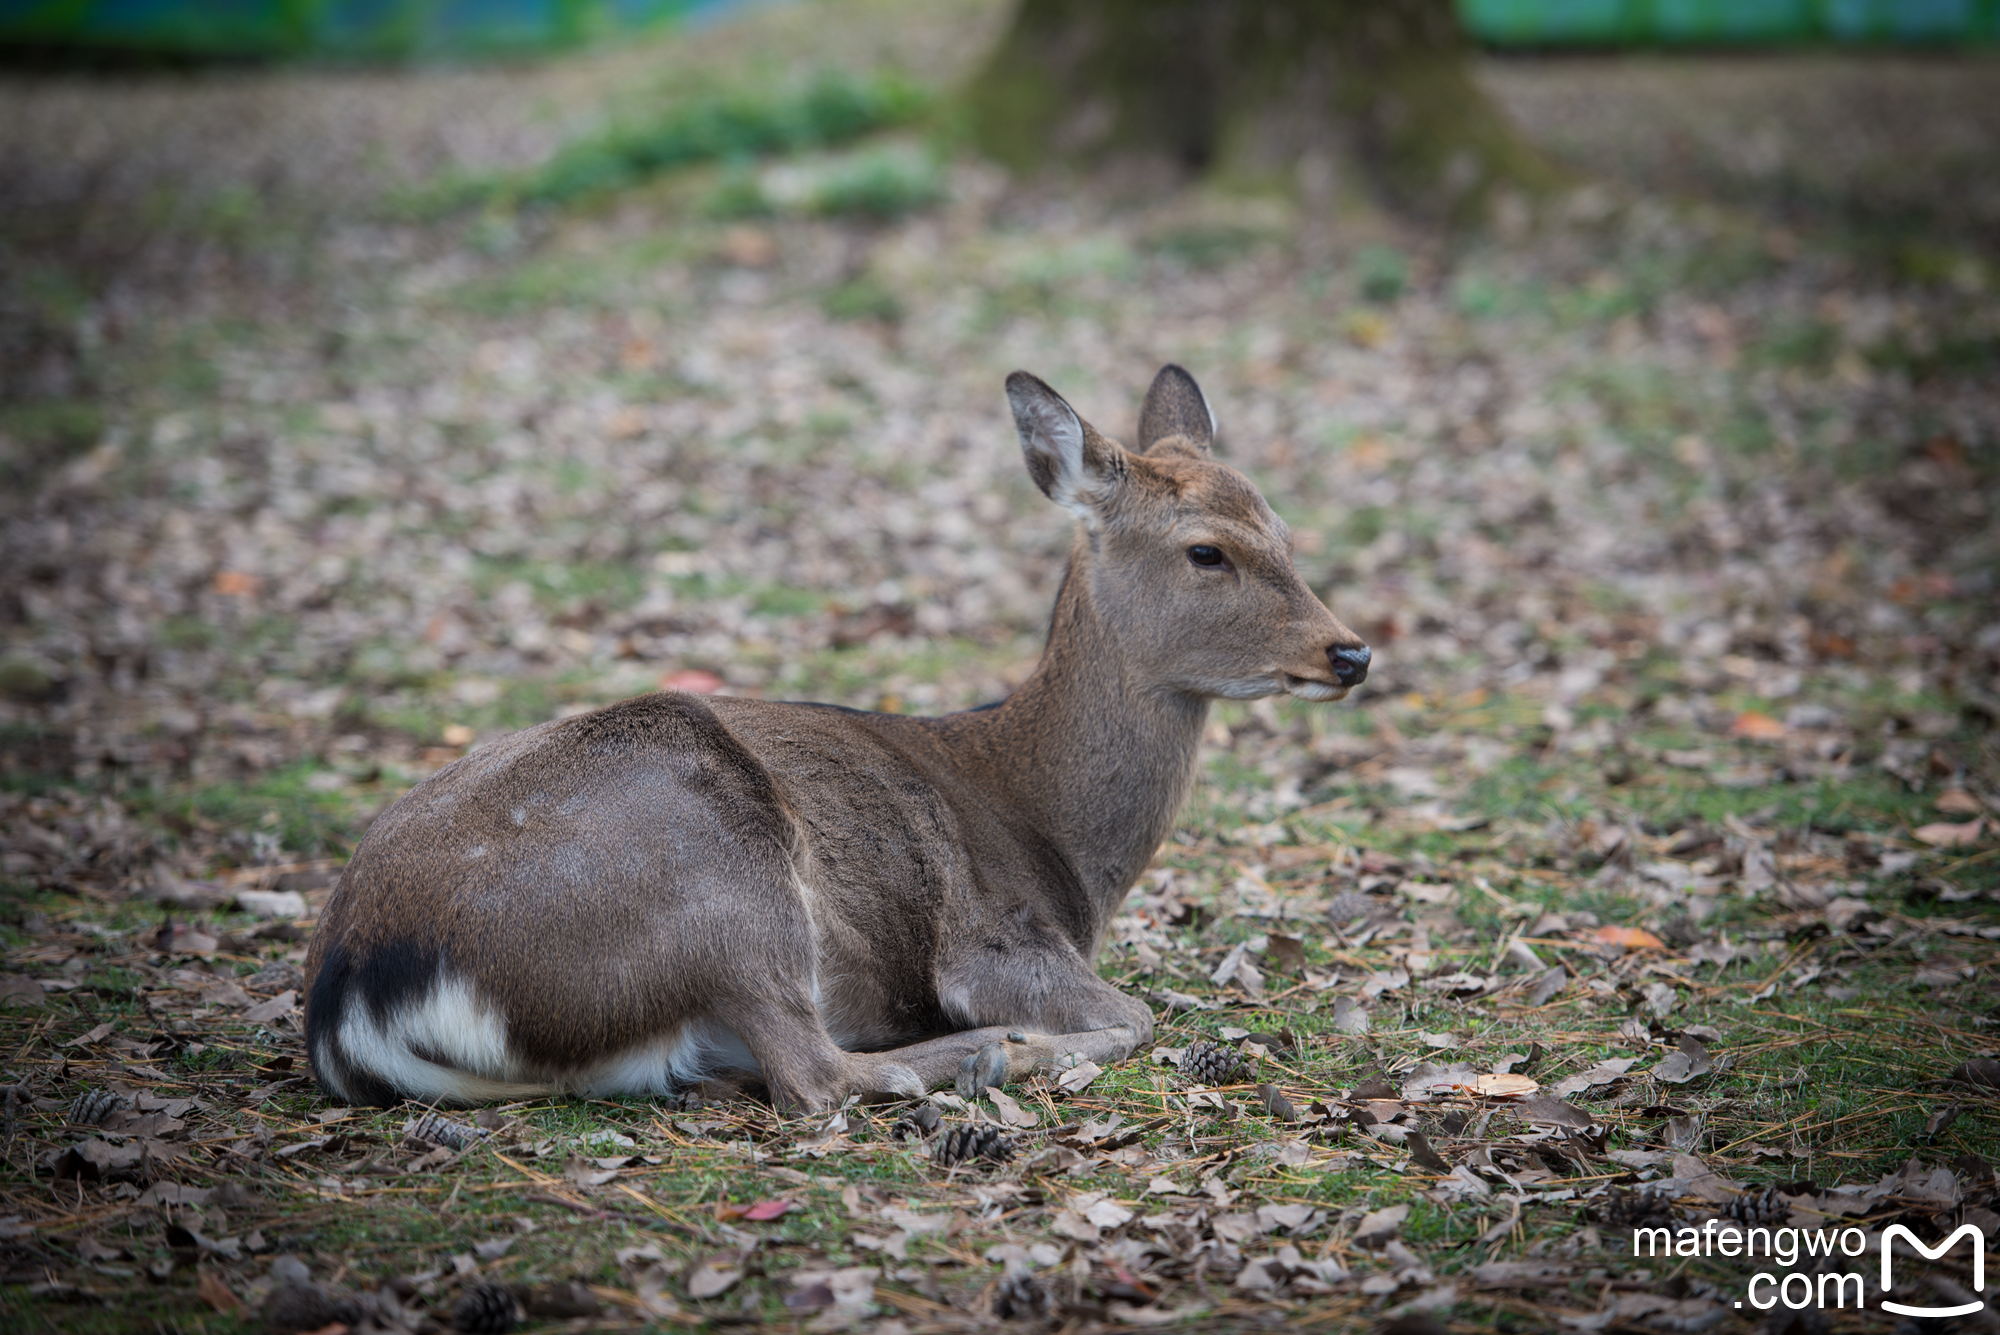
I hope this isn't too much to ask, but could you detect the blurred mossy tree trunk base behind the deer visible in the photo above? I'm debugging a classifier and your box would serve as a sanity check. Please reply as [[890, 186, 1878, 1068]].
[[970, 0, 1556, 216]]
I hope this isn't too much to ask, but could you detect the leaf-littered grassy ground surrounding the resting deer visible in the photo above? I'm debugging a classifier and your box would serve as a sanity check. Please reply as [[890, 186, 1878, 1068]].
[[0, 0, 2000, 1335]]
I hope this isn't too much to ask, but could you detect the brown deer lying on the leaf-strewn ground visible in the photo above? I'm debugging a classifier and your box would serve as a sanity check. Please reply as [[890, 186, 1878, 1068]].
[[306, 366, 1368, 1109]]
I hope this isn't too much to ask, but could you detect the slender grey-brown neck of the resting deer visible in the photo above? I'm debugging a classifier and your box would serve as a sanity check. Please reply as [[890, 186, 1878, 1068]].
[[960, 552, 1208, 945]]
